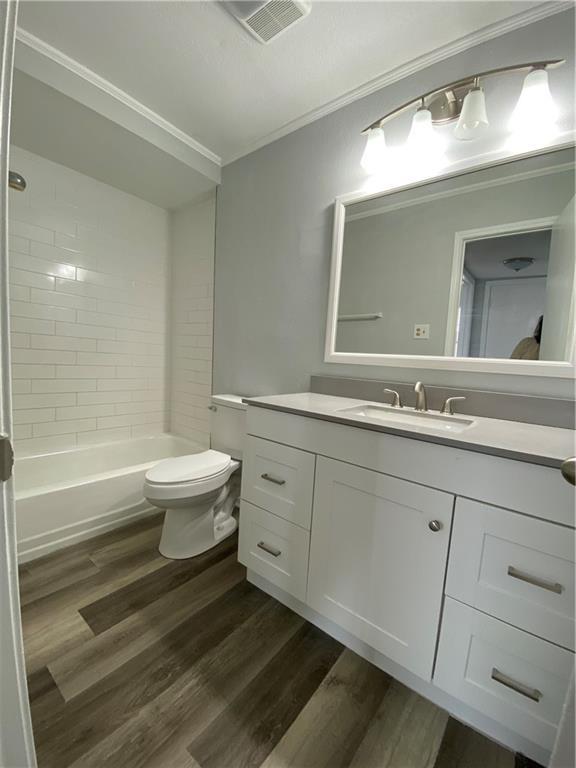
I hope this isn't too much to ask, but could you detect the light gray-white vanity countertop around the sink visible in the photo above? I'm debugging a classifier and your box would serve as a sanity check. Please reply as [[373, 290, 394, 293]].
[[245, 392, 576, 467]]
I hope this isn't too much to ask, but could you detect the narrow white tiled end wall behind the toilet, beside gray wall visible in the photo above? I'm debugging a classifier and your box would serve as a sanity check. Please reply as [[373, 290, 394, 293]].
[[170, 193, 216, 448]]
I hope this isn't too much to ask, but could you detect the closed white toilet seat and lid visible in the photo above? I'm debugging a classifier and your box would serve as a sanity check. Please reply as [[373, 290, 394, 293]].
[[144, 450, 240, 506]]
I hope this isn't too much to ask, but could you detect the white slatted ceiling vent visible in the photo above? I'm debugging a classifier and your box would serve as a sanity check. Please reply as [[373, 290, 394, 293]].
[[224, 0, 310, 43]]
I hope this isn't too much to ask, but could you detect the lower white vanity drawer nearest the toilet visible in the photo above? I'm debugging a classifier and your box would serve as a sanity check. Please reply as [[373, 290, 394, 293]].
[[238, 501, 310, 601]]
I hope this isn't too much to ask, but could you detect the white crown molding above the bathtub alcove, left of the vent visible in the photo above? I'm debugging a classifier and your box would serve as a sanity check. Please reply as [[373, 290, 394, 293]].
[[16, 27, 222, 167]]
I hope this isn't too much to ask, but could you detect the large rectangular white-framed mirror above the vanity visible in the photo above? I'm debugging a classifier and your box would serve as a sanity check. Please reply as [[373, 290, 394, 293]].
[[327, 147, 575, 372]]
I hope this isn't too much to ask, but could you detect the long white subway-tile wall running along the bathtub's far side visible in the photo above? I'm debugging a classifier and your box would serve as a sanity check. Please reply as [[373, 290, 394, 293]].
[[9, 147, 169, 455]]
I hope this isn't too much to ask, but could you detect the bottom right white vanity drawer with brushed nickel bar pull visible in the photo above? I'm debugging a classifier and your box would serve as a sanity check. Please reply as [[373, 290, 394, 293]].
[[434, 598, 574, 750]]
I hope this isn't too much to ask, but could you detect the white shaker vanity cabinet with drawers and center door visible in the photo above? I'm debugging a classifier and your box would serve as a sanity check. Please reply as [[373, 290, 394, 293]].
[[239, 406, 575, 764]]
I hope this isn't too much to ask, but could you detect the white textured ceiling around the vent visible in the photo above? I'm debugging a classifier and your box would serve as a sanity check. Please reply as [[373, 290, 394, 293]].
[[19, 0, 541, 162]]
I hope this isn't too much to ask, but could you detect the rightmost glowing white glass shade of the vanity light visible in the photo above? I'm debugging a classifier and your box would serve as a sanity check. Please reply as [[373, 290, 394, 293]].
[[508, 69, 558, 138]]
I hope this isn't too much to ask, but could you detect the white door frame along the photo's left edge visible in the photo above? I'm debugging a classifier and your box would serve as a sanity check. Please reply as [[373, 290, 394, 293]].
[[0, 0, 36, 768]]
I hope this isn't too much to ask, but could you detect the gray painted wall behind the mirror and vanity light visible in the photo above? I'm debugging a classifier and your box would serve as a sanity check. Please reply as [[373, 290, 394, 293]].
[[213, 10, 574, 397]]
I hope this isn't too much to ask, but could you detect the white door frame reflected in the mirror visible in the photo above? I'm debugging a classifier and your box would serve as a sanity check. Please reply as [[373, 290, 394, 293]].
[[444, 216, 558, 356]]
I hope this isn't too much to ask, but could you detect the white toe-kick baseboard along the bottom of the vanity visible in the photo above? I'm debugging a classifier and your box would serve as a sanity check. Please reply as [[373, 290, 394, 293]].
[[246, 570, 550, 765]]
